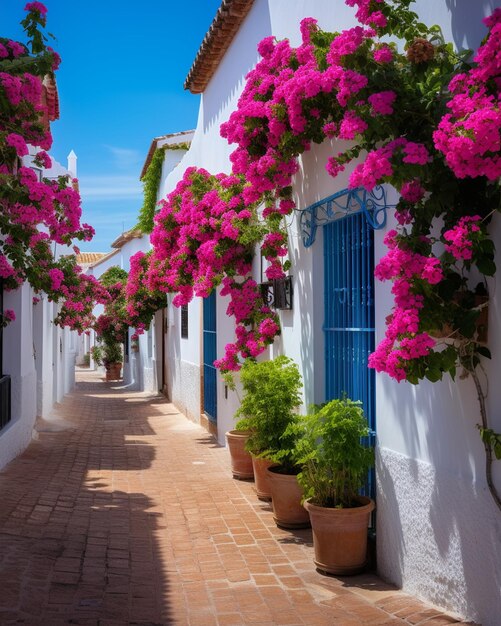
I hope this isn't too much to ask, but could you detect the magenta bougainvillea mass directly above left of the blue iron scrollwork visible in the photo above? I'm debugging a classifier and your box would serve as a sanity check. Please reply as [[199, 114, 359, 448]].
[[220, 18, 375, 217]]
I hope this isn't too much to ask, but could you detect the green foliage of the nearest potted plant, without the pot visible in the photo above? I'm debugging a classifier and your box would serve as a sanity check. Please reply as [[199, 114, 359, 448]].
[[297, 398, 374, 508]]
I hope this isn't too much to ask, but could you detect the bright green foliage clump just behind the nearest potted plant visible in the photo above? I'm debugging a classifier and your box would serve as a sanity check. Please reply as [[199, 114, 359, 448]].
[[235, 356, 303, 468]]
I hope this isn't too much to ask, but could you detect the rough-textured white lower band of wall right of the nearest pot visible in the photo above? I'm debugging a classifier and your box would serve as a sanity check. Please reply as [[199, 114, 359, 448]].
[[376, 444, 501, 626]]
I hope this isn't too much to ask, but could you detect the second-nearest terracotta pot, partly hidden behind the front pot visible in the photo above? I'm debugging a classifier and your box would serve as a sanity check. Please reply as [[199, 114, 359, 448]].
[[267, 466, 310, 528]]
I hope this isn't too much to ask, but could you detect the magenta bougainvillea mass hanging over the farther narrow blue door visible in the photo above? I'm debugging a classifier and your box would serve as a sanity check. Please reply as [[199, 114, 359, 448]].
[[146, 168, 286, 370]]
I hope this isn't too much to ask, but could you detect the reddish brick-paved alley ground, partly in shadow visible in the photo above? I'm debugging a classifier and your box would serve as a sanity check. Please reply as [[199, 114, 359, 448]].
[[0, 372, 476, 626]]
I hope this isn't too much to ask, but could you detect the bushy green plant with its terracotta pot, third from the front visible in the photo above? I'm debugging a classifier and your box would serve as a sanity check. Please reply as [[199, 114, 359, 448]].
[[235, 356, 303, 500]]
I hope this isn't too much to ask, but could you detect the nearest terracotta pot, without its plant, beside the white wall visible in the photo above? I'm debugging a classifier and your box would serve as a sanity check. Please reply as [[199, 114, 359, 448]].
[[304, 496, 375, 576]]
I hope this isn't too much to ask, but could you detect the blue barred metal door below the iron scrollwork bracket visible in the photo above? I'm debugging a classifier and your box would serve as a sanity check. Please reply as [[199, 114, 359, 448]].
[[324, 212, 376, 497]]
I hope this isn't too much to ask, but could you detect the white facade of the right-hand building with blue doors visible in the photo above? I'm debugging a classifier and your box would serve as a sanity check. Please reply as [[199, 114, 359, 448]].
[[152, 0, 501, 626]]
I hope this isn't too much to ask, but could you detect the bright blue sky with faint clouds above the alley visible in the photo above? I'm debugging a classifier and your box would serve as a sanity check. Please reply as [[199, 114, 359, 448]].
[[0, 0, 221, 252]]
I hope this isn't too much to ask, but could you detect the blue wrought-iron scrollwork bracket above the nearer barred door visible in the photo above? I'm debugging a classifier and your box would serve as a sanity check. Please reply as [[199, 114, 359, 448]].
[[299, 185, 396, 248]]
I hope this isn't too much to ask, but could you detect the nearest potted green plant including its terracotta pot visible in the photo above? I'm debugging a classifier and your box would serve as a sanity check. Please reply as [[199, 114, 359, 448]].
[[298, 398, 375, 575]]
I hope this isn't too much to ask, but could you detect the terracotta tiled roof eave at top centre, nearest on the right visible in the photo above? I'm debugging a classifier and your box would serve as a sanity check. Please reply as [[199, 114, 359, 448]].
[[184, 0, 254, 93]]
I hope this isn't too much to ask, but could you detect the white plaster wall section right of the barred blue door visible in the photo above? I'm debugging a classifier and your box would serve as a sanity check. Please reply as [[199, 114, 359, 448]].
[[375, 215, 501, 626]]
